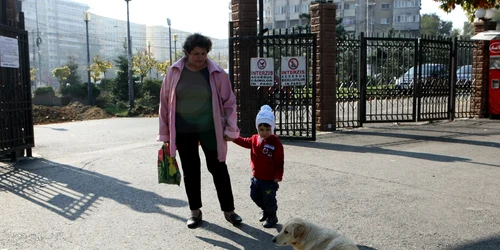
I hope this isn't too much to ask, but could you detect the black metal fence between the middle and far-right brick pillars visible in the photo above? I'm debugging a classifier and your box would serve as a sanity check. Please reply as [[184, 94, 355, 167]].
[[336, 33, 474, 128]]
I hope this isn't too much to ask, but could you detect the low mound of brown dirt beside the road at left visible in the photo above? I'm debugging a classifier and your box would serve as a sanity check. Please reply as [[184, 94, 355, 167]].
[[33, 102, 112, 124]]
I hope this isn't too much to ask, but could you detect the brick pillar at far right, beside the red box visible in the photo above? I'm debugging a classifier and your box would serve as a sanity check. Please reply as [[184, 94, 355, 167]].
[[471, 21, 496, 118]]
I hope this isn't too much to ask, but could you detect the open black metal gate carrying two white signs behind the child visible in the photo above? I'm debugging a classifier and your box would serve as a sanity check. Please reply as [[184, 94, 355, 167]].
[[229, 29, 316, 140]]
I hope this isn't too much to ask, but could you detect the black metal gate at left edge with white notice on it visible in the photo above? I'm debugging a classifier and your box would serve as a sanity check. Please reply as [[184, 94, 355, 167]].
[[0, 19, 34, 159]]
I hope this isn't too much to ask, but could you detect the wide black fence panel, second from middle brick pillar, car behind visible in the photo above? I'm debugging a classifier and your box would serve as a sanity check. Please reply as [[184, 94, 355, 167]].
[[365, 34, 418, 122]]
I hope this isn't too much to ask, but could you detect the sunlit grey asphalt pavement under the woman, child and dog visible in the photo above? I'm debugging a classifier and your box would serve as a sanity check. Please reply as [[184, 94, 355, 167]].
[[0, 118, 500, 250]]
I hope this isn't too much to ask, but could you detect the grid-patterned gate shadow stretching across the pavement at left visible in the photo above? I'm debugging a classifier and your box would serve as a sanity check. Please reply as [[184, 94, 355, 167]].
[[0, 158, 187, 221]]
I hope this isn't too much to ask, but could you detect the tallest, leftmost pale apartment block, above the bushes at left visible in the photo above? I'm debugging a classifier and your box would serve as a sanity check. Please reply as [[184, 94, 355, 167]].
[[22, 0, 89, 84]]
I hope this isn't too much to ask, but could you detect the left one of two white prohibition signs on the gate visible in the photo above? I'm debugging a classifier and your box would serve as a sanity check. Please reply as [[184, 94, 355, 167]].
[[250, 57, 274, 87]]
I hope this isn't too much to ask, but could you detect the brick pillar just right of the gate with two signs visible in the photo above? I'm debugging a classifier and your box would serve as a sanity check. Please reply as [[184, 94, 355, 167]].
[[310, 3, 337, 131]]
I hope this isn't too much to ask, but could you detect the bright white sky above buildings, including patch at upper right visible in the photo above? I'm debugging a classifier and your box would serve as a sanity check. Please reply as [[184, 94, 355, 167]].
[[74, 0, 467, 39]]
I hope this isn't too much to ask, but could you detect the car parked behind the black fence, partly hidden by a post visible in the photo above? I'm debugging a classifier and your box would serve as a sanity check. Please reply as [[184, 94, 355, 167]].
[[394, 63, 448, 89]]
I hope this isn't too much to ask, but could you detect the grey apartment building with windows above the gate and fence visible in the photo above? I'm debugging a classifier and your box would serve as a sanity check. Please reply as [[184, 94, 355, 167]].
[[264, 0, 421, 35]]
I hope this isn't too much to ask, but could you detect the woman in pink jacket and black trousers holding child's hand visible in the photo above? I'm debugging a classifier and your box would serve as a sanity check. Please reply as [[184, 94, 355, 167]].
[[158, 34, 242, 228]]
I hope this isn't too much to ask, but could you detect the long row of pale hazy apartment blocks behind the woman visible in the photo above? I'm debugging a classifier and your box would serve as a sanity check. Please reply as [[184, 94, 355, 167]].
[[22, 0, 229, 87]]
